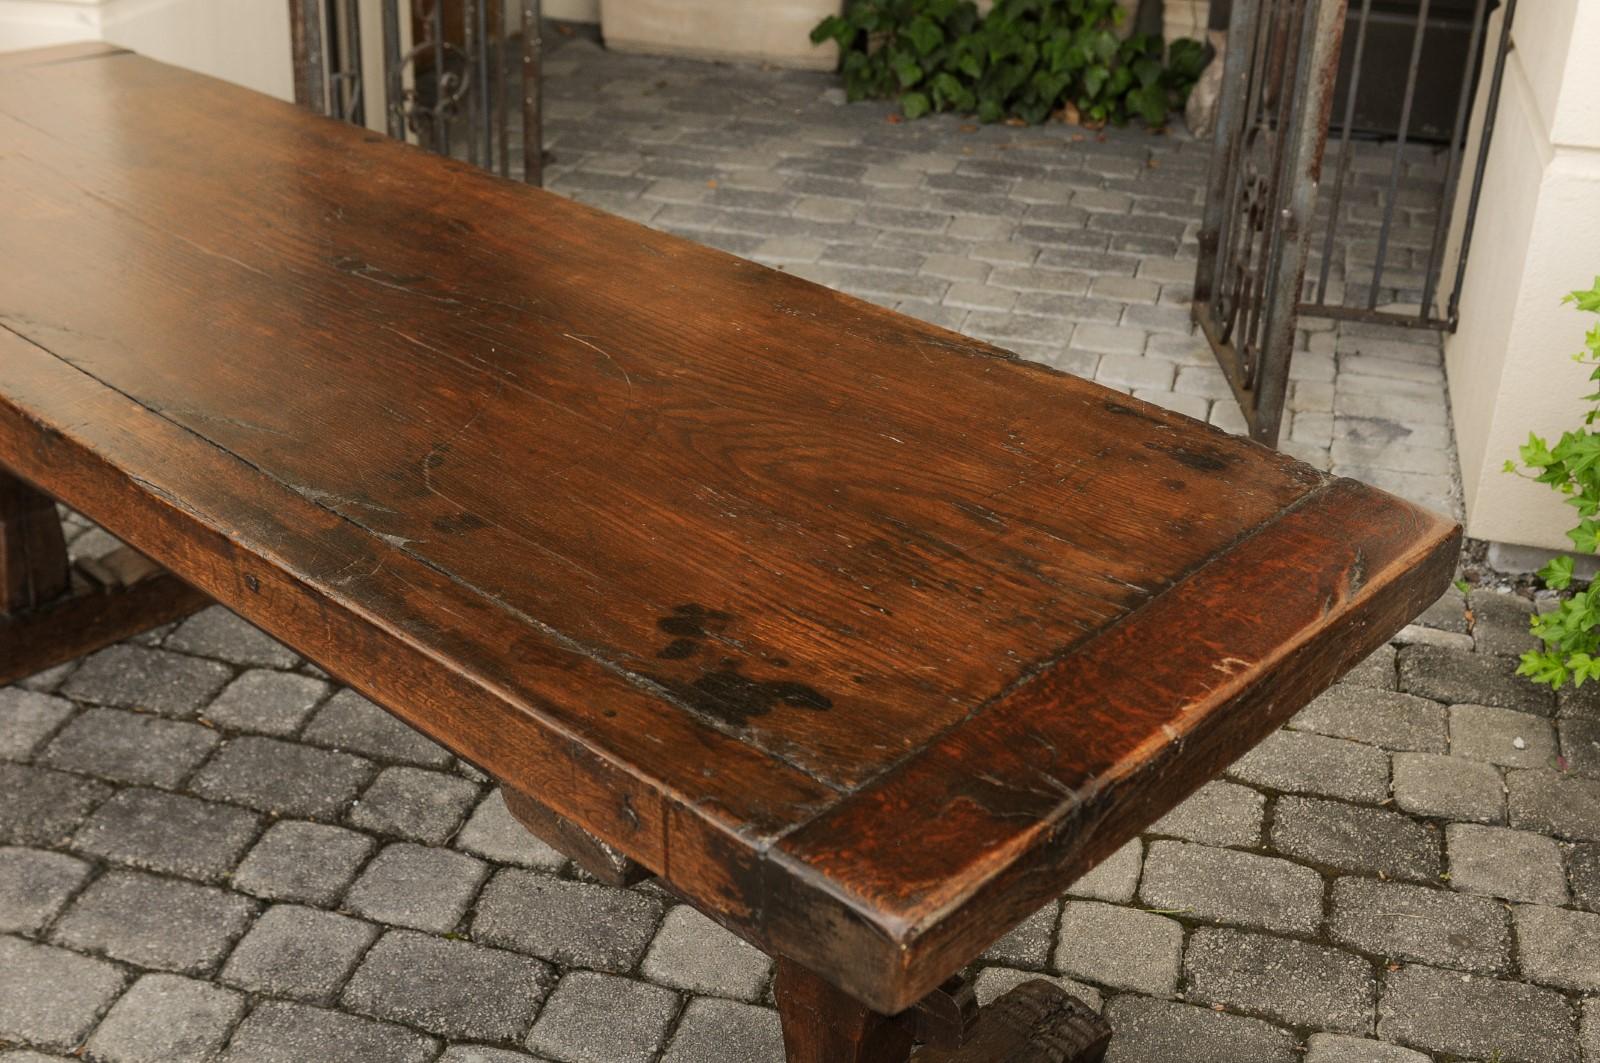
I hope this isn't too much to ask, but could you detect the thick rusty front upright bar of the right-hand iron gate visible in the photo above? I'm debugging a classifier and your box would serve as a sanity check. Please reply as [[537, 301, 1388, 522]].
[[1250, 0, 1350, 447]]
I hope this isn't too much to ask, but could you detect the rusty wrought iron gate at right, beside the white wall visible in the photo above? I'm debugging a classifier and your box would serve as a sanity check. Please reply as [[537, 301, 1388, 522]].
[[1194, 0, 1517, 445]]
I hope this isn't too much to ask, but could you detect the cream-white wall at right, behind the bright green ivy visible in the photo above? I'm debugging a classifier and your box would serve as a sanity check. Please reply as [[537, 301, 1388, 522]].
[[1445, 0, 1600, 549]]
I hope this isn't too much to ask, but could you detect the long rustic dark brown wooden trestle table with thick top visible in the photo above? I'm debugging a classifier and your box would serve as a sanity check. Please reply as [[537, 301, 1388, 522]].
[[0, 50, 1459, 1063]]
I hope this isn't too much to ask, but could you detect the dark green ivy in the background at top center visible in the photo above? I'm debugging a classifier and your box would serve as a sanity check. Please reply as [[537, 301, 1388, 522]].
[[811, 0, 1205, 126]]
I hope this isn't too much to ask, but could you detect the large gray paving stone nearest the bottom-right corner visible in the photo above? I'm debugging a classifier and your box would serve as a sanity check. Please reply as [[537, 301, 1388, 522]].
[[1378, 965, 1578, 1063]]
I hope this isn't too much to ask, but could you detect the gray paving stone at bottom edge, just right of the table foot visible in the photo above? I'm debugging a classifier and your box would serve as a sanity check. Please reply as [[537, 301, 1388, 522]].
[[1106, 994, 1299, 1063]]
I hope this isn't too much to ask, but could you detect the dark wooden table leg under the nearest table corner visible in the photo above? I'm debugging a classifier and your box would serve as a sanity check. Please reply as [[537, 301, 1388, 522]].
[[776, 957, 912, 1063]]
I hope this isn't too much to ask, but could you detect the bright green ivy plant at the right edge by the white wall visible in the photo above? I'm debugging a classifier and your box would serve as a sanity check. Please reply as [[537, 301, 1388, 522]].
[[1506, 277, 1600, 690]]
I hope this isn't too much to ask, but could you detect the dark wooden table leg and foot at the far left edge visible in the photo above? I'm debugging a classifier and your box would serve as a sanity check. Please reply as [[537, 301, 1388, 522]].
[[0, 471, 210, 687]]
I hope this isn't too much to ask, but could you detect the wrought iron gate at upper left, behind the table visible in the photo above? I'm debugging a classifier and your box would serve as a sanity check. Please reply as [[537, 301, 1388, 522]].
[[288, 0, 544, 184]]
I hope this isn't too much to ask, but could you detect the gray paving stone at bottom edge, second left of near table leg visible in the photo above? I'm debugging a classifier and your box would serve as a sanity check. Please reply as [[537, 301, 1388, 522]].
[[528, 970, 680, 1063]]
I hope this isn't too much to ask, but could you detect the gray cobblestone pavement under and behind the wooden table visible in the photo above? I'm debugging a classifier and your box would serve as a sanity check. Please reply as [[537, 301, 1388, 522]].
[[0, 29, 1561, 1063]]
